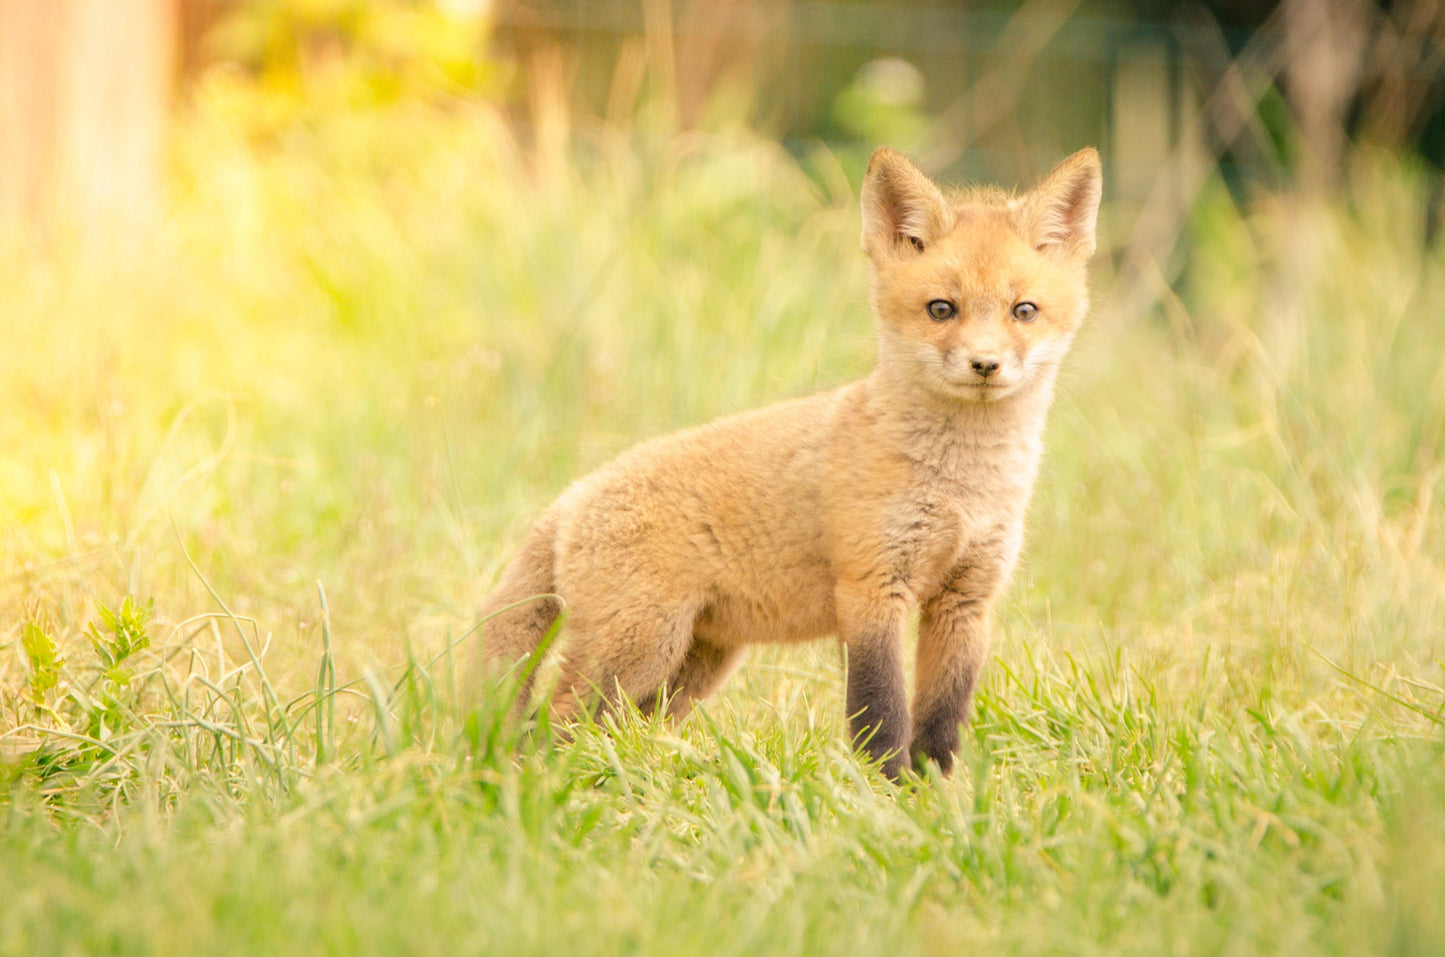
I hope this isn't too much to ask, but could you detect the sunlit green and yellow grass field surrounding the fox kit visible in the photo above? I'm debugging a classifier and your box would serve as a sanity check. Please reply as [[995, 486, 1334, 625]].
[[0, 71, 1445, 954]]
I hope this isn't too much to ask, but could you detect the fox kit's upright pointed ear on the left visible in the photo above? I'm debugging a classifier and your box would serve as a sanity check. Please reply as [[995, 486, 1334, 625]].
[[863, 149, 952, 256]]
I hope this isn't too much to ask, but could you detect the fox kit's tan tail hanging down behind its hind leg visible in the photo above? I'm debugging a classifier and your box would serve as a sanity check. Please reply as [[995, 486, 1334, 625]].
[[481, 513, 562, 714]]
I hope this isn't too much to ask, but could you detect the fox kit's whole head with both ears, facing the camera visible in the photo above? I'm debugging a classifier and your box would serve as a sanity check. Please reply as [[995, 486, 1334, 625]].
[[863, 149, 1101, 402]]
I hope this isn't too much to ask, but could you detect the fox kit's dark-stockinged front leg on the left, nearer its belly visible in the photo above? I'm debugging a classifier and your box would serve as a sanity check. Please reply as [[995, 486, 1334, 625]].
[[838, 588, 909, 781]]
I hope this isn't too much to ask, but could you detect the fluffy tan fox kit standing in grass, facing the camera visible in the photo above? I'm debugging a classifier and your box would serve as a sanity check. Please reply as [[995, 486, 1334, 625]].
[[483, 149, 1101, 778]]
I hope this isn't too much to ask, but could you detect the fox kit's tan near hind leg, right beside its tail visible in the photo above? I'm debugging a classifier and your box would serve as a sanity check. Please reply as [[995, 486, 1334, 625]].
[[552, 603, 698, 721]]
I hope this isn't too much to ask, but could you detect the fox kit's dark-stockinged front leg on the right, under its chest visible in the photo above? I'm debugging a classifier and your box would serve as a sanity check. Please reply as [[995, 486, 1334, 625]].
[[913, 588, 993, 775]]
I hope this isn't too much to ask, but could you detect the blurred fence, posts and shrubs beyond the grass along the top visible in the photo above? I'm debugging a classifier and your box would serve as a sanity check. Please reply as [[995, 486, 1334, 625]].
[[11, 0, 1445, 239]]
